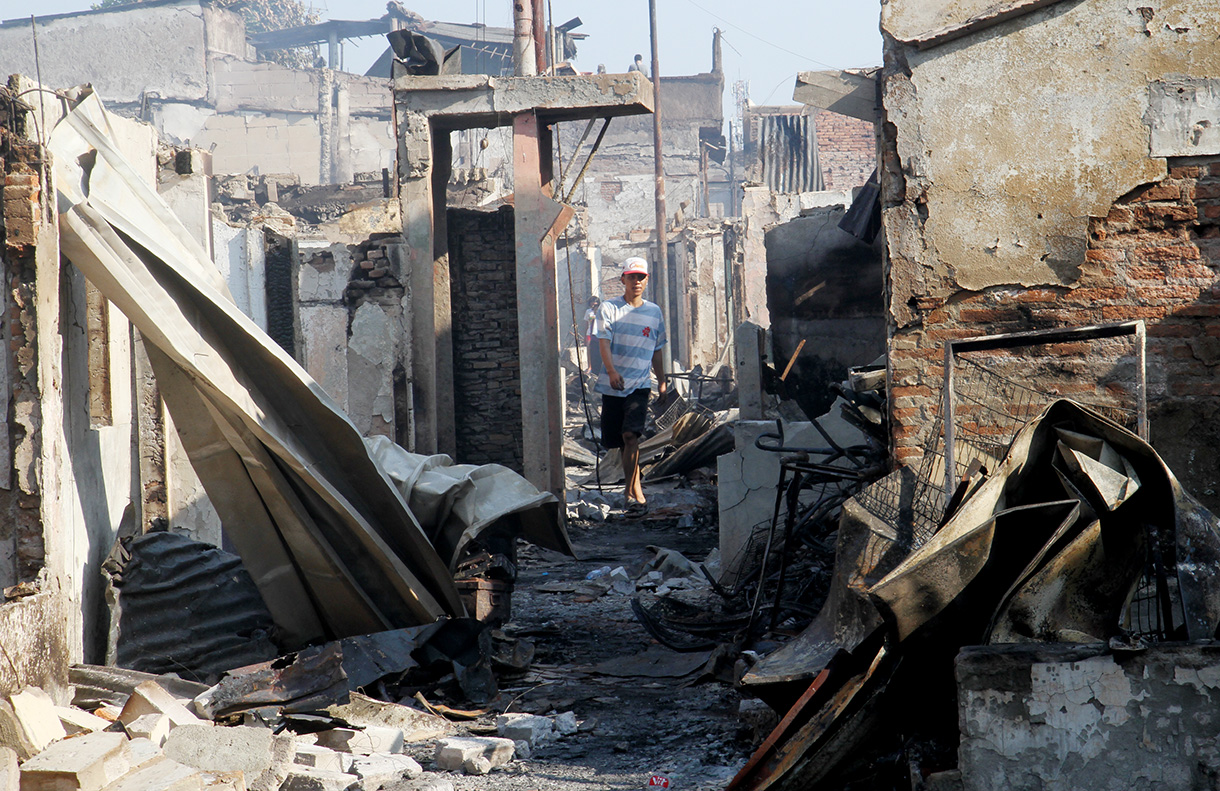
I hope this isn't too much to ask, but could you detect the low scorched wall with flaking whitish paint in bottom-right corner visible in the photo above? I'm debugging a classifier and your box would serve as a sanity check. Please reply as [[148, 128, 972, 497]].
[[955, 643, 1220, 791]]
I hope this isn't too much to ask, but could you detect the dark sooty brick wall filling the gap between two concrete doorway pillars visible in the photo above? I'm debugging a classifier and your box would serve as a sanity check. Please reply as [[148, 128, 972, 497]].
[[449, 208, 522, 472]]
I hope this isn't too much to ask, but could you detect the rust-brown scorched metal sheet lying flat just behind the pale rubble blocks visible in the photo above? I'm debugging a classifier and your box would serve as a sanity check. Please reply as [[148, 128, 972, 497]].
[[195, 643, 350, 719]]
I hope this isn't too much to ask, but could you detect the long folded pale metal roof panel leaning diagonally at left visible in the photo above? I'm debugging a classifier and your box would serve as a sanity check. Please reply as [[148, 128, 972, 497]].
[[50, 96, 462, 645]]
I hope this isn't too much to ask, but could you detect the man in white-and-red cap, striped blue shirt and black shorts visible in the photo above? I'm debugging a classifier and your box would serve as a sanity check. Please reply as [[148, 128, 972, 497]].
[[595, 258, 666, 513]]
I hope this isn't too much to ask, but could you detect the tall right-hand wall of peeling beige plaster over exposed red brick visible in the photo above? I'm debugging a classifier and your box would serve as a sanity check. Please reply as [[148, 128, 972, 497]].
[[883, 0, 1220, 507]]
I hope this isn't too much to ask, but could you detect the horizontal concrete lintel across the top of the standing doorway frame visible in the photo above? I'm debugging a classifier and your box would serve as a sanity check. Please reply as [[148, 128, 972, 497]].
[[394, 72, 655, 129]]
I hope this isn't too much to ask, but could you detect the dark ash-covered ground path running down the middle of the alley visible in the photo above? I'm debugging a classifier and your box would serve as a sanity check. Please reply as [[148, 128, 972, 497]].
[[417, 487, 750, 791]]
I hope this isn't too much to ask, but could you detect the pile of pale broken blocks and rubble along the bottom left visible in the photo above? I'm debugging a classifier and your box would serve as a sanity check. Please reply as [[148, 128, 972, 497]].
[[0, 665, 590, 791]]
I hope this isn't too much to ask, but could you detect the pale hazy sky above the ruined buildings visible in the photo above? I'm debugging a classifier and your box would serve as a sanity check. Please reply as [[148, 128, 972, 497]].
[[0, 0, 881, 108]]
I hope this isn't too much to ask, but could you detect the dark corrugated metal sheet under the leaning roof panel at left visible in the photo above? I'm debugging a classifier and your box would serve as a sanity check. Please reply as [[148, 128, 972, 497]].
[[102, 532, 279, 684]]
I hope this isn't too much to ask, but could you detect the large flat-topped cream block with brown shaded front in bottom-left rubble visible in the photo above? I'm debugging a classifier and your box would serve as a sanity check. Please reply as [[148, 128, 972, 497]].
[[21, 731, 131, 791]]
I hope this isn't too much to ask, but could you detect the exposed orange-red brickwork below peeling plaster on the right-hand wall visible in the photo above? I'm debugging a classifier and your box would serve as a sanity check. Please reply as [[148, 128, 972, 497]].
[[891, 157, 1220, 508]]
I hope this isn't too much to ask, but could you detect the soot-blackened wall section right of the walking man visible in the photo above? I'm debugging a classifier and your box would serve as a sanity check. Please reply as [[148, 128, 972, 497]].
[[766, 206, 886, 416]]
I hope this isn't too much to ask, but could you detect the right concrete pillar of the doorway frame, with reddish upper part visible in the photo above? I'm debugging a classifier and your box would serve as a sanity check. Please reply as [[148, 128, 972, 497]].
[[512, 112, 572, 497]]
